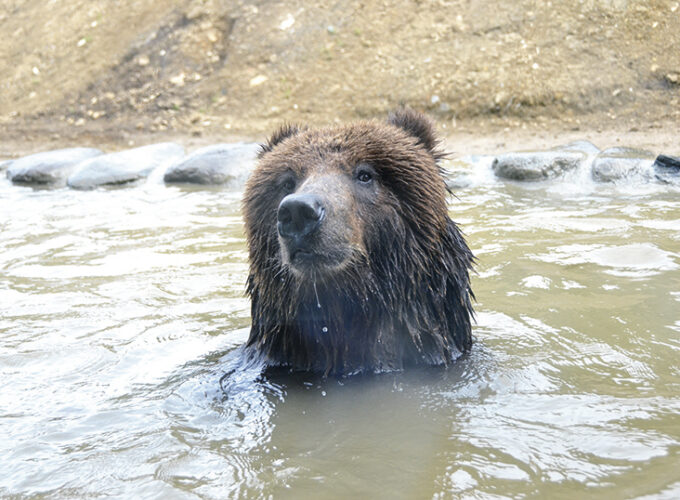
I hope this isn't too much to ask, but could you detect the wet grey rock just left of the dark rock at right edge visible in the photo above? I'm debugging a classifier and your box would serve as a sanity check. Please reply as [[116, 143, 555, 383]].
[[591, 147, 654, 182]]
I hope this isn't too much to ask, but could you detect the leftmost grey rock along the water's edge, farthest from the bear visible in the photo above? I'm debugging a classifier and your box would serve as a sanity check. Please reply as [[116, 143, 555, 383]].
[[7, 148, 103, 185]]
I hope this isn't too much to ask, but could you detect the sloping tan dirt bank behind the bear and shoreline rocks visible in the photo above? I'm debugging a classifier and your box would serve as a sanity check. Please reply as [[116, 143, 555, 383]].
[[0, 0, 680, 144]]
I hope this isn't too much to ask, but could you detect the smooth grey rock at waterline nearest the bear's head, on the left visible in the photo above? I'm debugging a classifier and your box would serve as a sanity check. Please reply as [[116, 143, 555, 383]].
[[163, 143, 260, 185]]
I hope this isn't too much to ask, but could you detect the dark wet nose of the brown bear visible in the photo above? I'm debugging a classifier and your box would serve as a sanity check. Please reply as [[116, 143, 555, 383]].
[[277, 193, 325, 238]]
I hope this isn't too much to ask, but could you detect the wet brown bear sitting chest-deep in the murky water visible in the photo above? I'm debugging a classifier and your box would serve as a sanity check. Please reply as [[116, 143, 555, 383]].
[[243, 109, 473, 376]]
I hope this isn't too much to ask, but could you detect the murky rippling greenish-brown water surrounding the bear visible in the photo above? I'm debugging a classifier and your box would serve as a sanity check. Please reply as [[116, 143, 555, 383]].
[[0, 159, 680, 499]]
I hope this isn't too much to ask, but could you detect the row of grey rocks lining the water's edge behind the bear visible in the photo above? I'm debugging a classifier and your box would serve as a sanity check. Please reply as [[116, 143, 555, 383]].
[[0, 140, 680, 190]]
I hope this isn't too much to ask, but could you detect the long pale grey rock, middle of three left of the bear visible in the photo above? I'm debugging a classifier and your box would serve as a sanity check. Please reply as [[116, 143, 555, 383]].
[[68, 142, 184, 189]]
